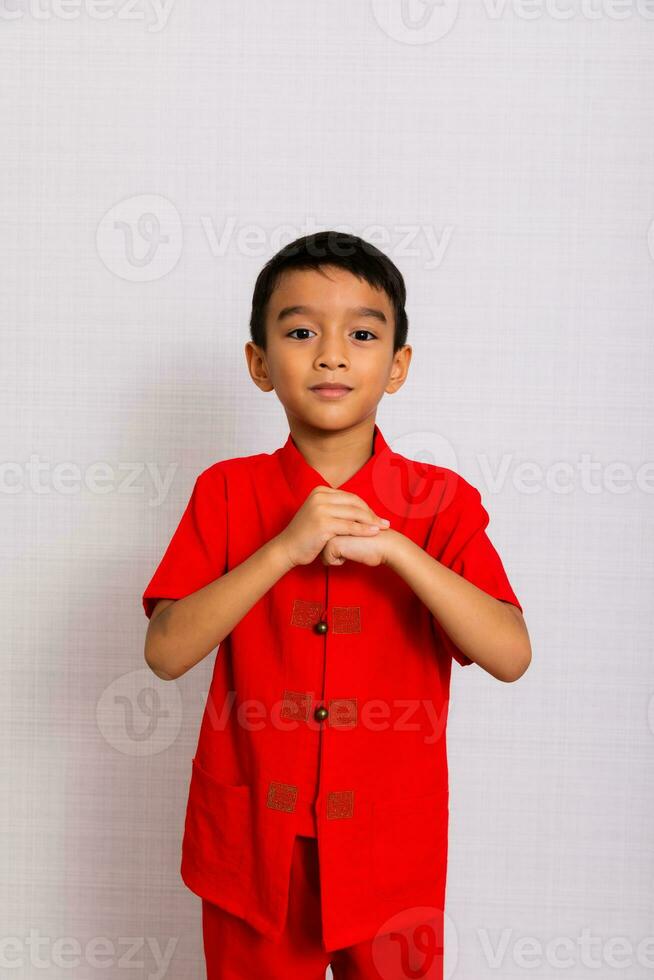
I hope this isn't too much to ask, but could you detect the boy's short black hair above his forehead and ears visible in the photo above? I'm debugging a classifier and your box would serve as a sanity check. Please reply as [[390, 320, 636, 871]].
[[250, 231, 409, 353]]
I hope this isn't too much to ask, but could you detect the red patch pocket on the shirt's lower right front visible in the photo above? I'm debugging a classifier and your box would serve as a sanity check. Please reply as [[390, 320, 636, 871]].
[[372, 789, 449, 898]]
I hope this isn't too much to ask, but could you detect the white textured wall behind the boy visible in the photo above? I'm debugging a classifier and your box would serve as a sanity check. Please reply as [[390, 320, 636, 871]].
[[0, 0, 654, 980]]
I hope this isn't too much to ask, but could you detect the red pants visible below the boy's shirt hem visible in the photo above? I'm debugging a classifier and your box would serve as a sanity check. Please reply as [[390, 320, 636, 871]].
[[202, 836, 443, 980]]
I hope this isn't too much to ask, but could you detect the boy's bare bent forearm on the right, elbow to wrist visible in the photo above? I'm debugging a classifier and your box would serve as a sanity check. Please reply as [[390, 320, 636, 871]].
[[380, 530, 531, 681]]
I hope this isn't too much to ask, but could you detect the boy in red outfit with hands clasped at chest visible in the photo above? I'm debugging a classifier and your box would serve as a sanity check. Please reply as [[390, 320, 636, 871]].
[[143, 232, 531, 980]]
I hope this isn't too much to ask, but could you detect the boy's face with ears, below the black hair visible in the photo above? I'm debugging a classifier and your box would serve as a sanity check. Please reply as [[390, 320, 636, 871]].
[[245, 266, 411, 430]]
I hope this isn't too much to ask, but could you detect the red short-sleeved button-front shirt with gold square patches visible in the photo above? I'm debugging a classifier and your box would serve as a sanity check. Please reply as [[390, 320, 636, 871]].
[[143, 425, 522, 950]]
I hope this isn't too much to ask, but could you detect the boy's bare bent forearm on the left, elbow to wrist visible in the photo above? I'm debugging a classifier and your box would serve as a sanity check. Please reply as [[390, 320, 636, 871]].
[[145, 538, 292, 681]]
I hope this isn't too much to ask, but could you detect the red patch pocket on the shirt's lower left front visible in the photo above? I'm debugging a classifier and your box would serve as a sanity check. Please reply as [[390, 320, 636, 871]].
[[184, 758, 251, 871]]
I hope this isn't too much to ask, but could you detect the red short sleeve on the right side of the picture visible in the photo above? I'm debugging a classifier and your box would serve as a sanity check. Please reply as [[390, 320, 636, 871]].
[[426, 471, 522, 667]]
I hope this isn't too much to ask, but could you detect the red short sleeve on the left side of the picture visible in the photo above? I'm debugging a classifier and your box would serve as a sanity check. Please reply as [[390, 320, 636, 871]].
[[143, 464, 227, 619]]
